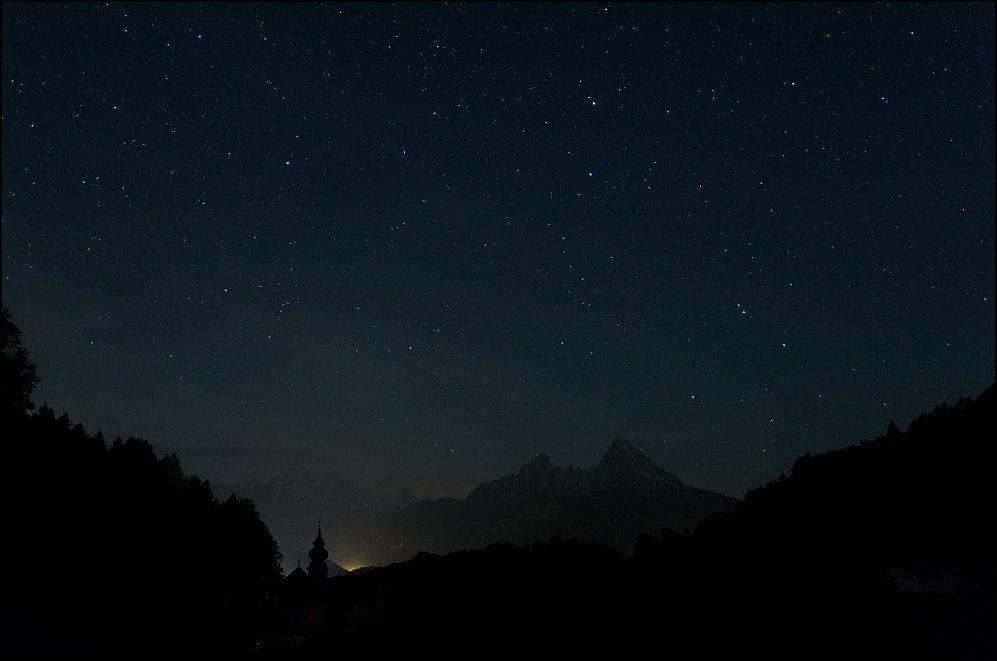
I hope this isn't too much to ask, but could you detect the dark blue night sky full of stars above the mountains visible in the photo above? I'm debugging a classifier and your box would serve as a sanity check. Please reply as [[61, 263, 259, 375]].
[[2, 3, 995, 497]]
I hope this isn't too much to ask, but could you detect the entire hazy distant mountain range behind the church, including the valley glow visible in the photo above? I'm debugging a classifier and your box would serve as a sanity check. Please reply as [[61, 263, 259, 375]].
[[216, 438, 739, 571]]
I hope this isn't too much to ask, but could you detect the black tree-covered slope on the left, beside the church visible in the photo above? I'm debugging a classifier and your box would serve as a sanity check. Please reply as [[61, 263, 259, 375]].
[[2, 310, 282, 658]]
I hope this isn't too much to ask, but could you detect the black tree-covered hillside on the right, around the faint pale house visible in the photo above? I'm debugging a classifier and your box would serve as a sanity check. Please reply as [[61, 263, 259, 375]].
[[635, 386, 997, 657]]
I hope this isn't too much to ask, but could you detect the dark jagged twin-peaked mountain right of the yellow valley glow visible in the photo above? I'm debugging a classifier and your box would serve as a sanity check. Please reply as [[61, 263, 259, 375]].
[[365, 438, 740, 564]]
